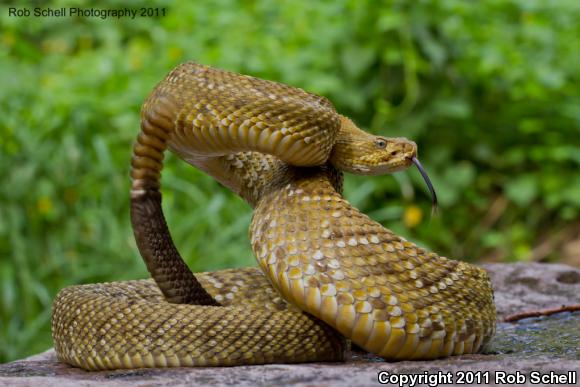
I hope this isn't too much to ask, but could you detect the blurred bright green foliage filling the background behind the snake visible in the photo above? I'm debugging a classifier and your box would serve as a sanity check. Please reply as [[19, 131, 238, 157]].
[[0, 0, 580, 362]]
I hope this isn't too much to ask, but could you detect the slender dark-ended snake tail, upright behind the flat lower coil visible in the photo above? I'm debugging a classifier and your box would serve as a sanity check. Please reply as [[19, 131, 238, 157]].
[[131, 91, 219, 305]]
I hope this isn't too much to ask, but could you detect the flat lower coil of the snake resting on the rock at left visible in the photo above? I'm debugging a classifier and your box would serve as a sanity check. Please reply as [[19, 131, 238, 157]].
[[52, 268, 348, 370]]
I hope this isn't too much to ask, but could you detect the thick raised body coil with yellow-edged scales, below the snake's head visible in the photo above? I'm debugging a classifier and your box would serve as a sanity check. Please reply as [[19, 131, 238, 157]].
[[251, 169, 495, 359]]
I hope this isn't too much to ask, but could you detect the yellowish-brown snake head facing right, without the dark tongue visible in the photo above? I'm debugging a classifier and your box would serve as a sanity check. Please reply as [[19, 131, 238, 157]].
[[329, 116, 417, 175]]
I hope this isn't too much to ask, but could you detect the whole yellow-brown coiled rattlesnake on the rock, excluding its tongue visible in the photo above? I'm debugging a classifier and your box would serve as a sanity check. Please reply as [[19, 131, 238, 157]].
[[52, 63, 495, 370]]
